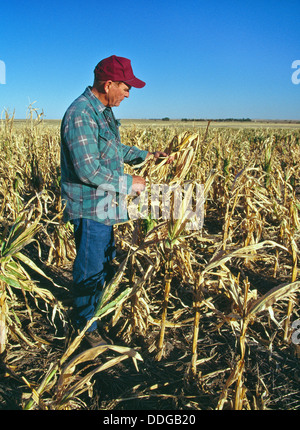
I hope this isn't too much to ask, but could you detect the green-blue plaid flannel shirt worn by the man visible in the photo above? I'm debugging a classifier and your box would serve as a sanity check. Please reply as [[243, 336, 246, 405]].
[[61, 87, 148, 225]]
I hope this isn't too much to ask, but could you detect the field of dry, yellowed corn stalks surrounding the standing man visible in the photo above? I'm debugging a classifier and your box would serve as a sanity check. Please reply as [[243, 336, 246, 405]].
[[0, 106, 300, 410]]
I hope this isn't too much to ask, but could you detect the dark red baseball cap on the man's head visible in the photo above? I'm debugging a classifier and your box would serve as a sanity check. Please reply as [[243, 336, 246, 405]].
[[94, 55, 146, 88]]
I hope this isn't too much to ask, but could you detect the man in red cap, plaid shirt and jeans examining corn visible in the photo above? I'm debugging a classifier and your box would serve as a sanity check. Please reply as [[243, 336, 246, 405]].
[[61, 55, 167, 346]]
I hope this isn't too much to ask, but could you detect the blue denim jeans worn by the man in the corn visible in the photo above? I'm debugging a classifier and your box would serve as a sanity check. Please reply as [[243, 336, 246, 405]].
[[72, 219, 115, 331]]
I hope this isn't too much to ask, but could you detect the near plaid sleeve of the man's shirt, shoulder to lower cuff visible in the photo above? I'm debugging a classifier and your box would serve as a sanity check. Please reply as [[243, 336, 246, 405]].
[[64, 113, 132, 194]]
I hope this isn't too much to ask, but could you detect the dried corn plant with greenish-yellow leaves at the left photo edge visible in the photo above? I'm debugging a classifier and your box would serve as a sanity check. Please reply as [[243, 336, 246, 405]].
[[0, 197, 62, 351]]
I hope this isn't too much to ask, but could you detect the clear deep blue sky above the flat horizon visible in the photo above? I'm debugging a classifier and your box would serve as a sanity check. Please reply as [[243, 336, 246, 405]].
[[0, 0, 300, 119]]
